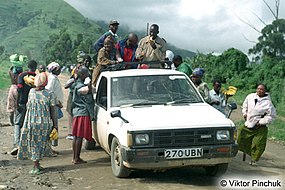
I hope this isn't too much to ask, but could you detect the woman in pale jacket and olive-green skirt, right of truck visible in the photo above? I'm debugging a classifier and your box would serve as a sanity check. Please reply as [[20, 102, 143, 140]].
[[237, 84, 276, 165]]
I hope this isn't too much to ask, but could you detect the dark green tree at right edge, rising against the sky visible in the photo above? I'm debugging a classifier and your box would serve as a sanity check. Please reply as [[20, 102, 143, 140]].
[[249, 19, 285, 60]]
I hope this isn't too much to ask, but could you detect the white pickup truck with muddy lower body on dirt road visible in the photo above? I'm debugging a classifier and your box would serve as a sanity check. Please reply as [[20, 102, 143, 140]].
[[88, 66, 238, 177]]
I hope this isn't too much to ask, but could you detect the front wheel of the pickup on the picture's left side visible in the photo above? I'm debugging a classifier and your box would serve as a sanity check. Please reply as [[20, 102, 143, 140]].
[[111, 137, 131, 178]]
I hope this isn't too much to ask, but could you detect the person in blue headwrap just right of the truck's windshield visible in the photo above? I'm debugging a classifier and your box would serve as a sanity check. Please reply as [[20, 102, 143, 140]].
[[190, 68, 210, 103]]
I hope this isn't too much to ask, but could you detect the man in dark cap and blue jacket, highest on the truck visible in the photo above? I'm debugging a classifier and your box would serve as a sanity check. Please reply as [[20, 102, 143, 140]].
[[93, 20, 119, 52]]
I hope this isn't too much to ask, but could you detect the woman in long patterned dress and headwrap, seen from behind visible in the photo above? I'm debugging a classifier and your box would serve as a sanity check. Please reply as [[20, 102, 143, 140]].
[[18, 72, 58, 175]]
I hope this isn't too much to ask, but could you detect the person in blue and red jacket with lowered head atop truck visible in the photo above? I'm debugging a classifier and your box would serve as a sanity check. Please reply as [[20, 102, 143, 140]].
[[115, 32, 138, 68]]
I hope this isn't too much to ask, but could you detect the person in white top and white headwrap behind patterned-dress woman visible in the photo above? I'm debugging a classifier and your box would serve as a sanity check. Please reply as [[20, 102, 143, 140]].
[[45, 62, 63, 148]]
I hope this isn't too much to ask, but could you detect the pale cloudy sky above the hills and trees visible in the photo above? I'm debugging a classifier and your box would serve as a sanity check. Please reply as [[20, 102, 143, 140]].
[[65, 0, 285, 54]]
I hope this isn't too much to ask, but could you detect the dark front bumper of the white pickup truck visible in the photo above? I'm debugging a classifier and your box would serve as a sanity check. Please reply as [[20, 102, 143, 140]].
[[121, 144, 238, 170]]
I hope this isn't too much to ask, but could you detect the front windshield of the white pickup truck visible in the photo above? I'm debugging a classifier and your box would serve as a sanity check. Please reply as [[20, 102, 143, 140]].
[[111, 75, 203, 107]]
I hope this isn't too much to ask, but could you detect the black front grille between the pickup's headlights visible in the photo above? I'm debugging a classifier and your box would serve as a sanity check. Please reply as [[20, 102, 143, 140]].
[[153, 128, 228, 147]]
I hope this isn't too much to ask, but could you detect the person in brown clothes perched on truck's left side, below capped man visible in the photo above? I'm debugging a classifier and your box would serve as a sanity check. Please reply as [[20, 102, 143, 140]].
[[92, 37, 122, 86]]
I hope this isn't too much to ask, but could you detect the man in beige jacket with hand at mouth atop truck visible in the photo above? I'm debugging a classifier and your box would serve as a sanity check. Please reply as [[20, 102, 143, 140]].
[[136, 24, 167, 67]]
